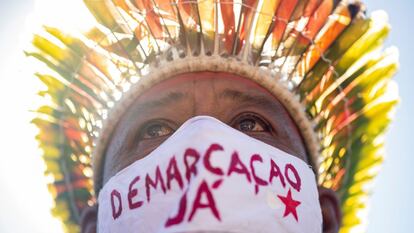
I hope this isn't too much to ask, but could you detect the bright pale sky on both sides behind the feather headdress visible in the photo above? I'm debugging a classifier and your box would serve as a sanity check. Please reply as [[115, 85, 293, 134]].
[[0, 0, 414, 233]]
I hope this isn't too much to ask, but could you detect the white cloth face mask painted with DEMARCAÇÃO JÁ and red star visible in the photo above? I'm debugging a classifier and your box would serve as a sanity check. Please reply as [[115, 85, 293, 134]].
[[98, 116, 322, 233]]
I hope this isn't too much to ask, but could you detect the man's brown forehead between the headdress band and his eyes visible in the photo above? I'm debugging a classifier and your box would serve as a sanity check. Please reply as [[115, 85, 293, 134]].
[[128, 72, 282, 113]]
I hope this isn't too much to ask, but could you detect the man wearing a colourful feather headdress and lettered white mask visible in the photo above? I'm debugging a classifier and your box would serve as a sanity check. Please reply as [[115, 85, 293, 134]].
[[30, 0, 396, 232]]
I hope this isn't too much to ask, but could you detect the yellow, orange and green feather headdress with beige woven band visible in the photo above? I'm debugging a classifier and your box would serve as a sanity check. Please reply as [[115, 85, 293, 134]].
[[27, 0, 398, 233]]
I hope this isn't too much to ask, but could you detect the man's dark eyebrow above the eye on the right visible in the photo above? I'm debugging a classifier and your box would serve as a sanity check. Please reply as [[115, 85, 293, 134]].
[[218, 89, 280, 108]]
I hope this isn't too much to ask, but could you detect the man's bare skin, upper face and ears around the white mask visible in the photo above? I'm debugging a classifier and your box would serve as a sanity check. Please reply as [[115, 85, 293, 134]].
[[82, 72, 340, 233]]
